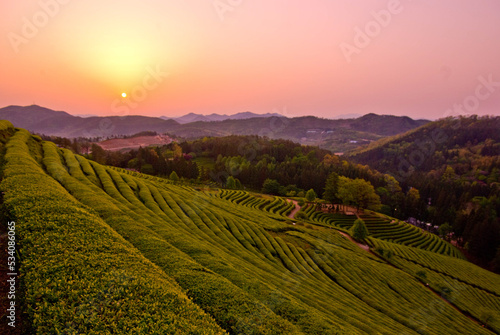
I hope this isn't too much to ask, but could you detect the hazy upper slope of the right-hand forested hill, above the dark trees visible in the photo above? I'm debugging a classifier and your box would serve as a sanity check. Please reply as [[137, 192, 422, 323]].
[[349, 116, 500, 179]]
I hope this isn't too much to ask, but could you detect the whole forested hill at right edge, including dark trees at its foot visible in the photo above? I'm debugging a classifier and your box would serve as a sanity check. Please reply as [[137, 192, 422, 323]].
[[349, 116, 500, 268]]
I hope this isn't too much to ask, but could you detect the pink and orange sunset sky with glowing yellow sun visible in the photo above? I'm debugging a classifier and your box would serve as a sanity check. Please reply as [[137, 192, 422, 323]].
[[0, 0, 500, 119]]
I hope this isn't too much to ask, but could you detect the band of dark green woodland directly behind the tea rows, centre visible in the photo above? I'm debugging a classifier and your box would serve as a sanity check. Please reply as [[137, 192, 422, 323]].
[[186, 136, 420, 217]]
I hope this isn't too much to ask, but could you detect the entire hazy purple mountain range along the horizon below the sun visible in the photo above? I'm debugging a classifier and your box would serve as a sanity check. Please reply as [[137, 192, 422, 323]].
[[0, 105, 429, 152]]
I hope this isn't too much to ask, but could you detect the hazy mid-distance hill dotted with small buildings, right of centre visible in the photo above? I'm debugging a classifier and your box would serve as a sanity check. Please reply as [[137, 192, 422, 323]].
[[150, 114, 428, 152]]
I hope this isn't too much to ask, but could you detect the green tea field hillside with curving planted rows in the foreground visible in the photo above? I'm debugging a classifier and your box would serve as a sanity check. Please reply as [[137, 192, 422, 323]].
[[0, 121, 500, 335]]
